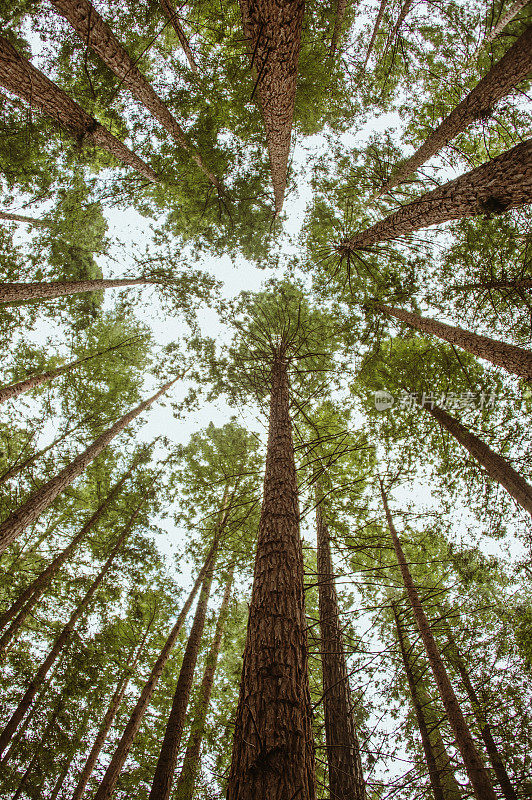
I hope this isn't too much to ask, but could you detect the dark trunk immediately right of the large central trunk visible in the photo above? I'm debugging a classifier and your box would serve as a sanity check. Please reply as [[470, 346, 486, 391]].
[[316, 489, 366, 800]]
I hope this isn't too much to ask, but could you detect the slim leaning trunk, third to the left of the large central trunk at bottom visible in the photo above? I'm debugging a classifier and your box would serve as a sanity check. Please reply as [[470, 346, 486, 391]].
[[94, 536, 218, 800]]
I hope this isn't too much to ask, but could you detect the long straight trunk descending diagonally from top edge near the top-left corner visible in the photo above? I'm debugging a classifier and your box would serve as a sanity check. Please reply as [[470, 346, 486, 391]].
[[46, 0, 221, 189]]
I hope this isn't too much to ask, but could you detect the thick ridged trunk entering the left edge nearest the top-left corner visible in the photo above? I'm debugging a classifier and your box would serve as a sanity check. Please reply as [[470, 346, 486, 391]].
[[0, 36, 159, 183]]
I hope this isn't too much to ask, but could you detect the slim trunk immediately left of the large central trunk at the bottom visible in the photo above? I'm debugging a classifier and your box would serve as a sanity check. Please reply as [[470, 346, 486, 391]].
[[173, 566, 234, 800]]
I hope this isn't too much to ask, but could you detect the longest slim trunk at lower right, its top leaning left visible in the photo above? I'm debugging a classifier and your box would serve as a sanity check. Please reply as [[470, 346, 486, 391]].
[[380, 481, 497, 800]]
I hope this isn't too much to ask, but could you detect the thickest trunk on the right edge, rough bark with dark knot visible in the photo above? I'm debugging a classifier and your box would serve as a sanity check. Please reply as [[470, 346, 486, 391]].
[[336, 139, 532, 255]]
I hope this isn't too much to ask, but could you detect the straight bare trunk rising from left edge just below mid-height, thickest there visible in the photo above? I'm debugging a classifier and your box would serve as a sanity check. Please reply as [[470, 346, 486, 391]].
[[0, 378, 178, 553]]
